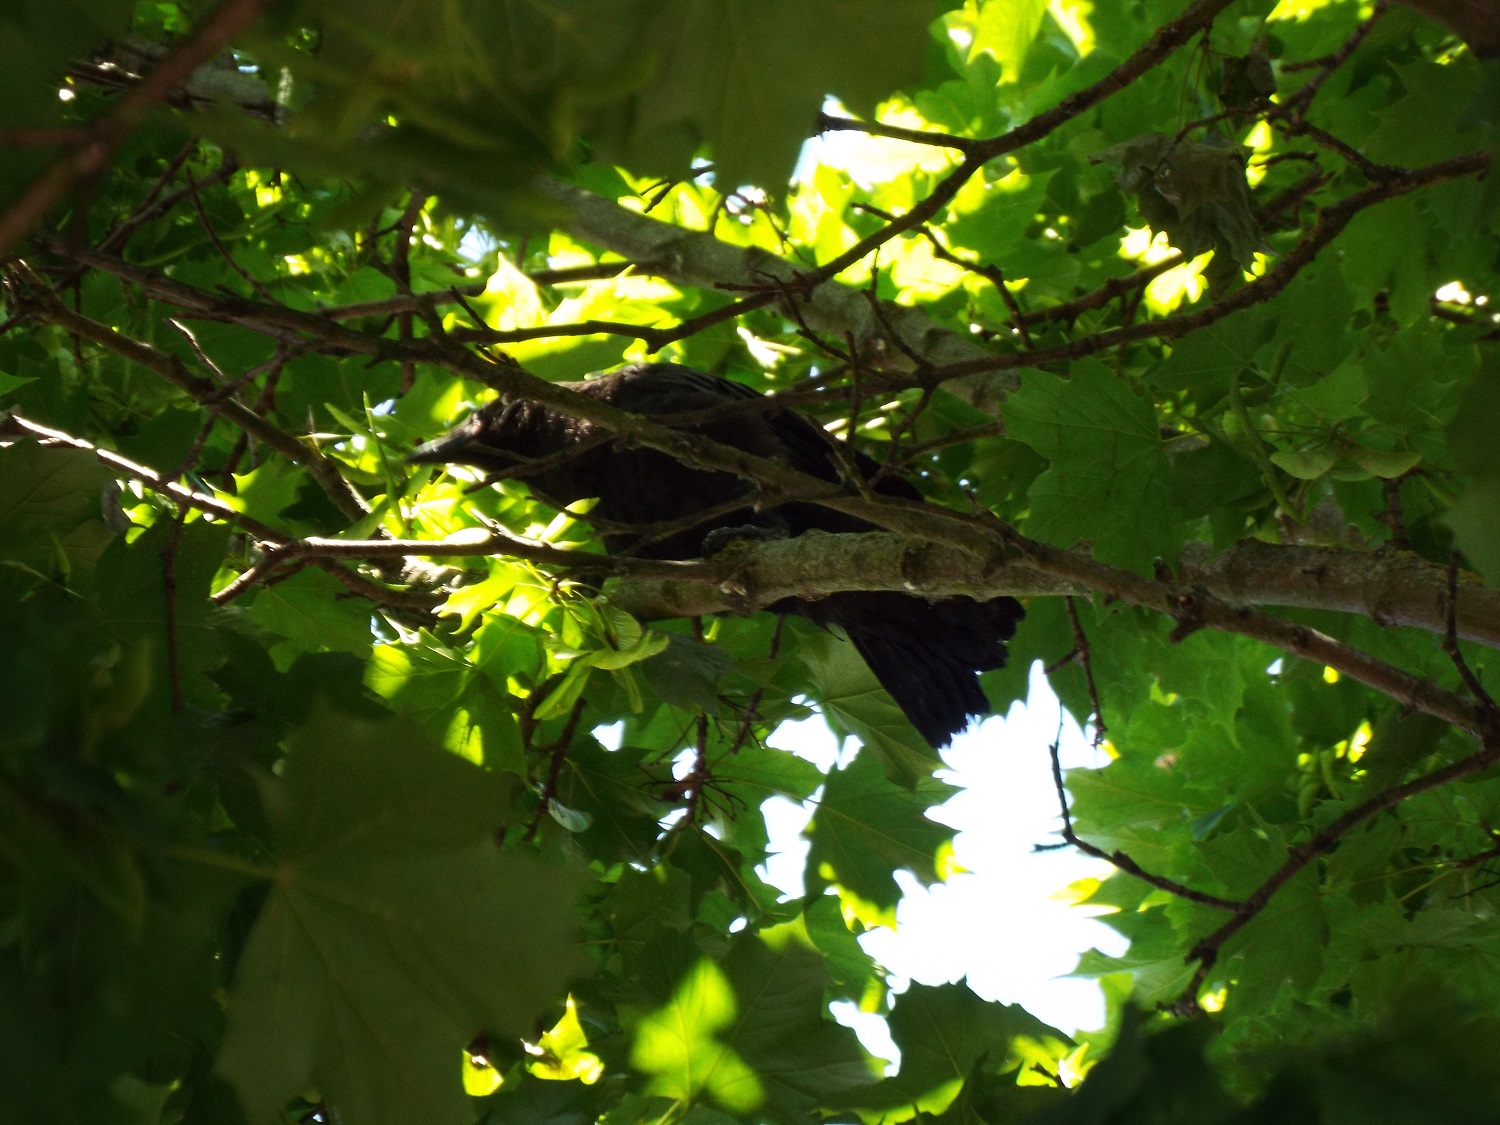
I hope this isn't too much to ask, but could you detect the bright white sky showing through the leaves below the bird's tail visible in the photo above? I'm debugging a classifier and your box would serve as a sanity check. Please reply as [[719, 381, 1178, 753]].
[[764, 665, 1127, 1058]]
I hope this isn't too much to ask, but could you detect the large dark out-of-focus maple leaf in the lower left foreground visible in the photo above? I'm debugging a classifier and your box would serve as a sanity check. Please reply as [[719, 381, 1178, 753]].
[[219, 713, 581, 1125]]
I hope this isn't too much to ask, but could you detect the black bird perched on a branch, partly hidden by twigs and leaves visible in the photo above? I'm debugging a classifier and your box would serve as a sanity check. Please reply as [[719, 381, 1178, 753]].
[[410, 363, 1025, 747]]
